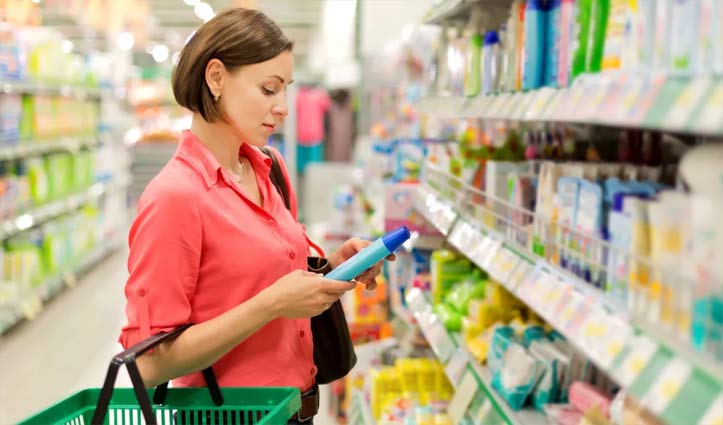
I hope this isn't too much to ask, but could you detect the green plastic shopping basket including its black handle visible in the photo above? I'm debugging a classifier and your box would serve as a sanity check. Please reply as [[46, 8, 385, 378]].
[[20, 325, 301, 425]]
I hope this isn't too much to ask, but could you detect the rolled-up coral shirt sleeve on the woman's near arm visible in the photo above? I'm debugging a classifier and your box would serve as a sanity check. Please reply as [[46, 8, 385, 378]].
[[119, 184, 202, 348]]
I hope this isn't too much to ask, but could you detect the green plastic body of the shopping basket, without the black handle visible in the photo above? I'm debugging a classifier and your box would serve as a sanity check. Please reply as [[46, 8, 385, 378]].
[[20, 387, 301, 425]]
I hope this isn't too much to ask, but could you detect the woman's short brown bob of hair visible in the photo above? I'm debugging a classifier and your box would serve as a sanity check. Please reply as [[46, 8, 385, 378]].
[[172, 8, 293, 122]]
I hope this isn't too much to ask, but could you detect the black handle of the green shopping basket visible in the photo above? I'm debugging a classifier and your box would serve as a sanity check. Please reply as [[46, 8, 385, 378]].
[[91, 324, 223, 425]]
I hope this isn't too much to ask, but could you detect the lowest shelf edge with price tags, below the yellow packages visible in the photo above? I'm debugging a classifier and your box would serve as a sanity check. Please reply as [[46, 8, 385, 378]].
[[406, 288, 548, 425]]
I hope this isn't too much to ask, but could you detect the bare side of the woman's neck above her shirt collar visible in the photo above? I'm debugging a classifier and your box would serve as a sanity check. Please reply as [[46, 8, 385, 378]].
[[191, 114, 243, 171]]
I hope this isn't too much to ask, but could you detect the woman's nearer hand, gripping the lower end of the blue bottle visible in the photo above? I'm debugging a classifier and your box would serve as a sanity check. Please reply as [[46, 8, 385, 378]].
[[262, 270, 356, 319]]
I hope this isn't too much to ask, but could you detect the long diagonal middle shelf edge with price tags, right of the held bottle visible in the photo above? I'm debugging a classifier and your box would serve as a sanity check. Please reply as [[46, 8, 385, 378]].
[[416, 167, 723, 423]]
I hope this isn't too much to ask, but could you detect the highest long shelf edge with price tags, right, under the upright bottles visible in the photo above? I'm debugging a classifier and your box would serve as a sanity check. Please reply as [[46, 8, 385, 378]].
[[418, 75, 723, 136]]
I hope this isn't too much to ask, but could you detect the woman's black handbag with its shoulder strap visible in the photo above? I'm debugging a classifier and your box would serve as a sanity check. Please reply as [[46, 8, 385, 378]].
[[261, 148, 356, 384]]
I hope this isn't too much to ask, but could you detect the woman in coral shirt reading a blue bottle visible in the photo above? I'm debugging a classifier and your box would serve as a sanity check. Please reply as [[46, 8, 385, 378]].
[[120, 9, 390, 423]]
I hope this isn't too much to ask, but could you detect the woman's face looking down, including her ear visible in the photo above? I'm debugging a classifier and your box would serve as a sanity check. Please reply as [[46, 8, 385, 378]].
[[218, 51, 294, 146]]
